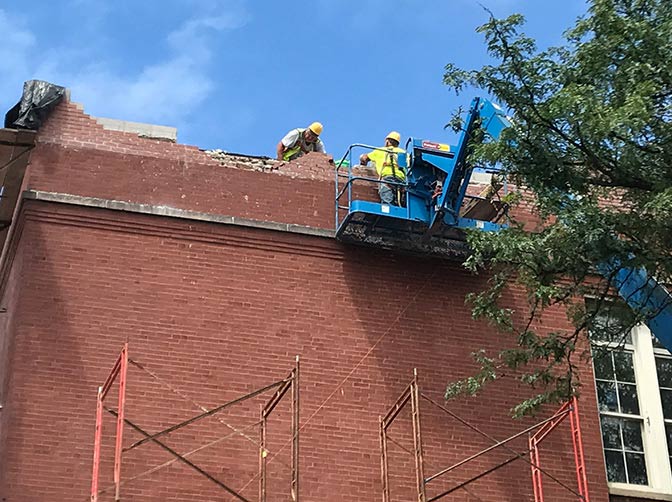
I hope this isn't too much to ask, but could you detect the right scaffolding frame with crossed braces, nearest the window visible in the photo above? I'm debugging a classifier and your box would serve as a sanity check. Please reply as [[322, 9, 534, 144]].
[[379, 369, 590, 502]]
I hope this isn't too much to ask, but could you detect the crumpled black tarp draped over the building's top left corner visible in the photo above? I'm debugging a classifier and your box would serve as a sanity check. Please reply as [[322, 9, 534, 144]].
[[5, 80, 65, 131]]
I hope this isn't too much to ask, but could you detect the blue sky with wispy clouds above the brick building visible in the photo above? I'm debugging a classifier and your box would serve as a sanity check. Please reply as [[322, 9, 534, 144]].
[[0, 0, 586, 157]]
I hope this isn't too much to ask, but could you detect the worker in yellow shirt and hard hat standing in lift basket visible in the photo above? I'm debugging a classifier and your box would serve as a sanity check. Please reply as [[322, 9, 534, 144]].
[[359, 131, 406, 206]]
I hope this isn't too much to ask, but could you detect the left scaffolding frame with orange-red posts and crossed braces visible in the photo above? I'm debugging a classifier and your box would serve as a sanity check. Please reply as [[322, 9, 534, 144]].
[[90, 342, 300, 502]]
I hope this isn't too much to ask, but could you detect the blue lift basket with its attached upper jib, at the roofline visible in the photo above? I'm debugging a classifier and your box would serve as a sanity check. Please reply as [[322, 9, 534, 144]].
[[336, 98, 510, 256]]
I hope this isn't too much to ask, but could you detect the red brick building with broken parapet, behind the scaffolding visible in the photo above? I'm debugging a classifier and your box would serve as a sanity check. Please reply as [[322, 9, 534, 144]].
[[0, 83, 672, 502]]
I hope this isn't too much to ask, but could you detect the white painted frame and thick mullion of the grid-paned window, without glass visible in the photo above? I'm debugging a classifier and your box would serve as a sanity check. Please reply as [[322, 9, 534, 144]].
[[593, 325, 672, 501]]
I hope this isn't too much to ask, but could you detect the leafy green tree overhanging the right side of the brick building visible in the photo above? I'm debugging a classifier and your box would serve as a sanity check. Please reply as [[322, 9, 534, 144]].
[[444, 0, 672, 415]]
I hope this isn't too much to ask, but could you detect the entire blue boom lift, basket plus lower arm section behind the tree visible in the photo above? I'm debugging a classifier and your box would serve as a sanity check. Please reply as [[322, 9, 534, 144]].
[[336, 98, 672, 352]]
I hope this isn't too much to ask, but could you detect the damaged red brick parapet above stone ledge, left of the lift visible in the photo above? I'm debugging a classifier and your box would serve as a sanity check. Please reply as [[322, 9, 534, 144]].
[[26, 97, 342, 229]]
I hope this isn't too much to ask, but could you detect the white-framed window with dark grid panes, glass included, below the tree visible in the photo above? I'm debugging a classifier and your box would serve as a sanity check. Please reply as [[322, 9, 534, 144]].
[[593, 321, 672, 494]]
